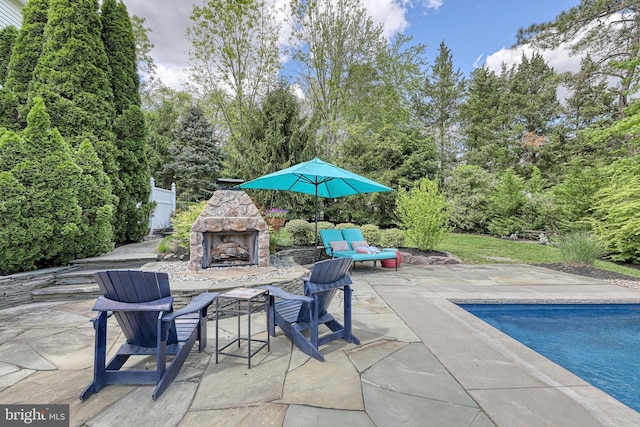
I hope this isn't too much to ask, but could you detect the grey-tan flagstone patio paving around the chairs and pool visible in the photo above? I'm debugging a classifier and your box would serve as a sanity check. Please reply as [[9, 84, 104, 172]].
[[0, 252, 640, 427]]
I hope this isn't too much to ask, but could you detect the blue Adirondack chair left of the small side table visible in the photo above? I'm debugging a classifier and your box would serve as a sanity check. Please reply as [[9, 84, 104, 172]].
[[80, 270, 217, 400]]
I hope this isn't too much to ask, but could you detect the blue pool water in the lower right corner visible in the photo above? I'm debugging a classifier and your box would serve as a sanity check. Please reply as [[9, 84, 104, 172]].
[[459, 304, 640, 412]]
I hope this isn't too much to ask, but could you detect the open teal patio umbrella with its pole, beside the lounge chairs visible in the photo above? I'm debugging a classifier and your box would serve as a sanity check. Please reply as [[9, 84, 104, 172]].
[[239, 157, 393, 256]]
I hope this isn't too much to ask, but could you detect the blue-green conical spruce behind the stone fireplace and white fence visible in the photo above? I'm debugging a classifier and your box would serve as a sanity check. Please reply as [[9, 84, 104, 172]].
[[167, 106, 222, 201]]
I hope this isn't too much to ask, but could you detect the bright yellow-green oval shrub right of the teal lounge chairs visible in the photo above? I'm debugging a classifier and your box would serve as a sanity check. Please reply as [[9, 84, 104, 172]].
[[396, 178, 449, 251]]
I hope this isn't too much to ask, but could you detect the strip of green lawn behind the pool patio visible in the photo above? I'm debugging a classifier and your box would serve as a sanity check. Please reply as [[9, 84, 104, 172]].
[[435, 233, 640, 277]]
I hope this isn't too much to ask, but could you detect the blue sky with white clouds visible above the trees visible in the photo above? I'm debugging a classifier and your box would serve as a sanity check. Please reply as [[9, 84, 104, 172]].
[[123, 0, 580, 89]]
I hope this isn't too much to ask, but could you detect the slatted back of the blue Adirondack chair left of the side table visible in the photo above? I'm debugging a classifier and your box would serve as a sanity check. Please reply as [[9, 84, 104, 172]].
[[94, 270, 178, 348]]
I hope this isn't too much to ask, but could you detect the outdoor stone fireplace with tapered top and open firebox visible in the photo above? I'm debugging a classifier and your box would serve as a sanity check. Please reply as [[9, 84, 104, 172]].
[[189, 190, 269, 271]]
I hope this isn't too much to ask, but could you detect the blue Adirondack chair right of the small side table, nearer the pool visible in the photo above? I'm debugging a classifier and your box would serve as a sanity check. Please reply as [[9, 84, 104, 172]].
[[265, 258, 360, 361]]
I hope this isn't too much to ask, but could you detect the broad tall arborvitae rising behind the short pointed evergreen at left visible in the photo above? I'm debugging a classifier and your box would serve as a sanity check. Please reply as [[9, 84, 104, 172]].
[[29, 0, 114, 141]]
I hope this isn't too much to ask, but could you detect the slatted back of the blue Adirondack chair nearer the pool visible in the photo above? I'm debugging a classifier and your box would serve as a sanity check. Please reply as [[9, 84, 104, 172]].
[[298, 258, 353, 322]]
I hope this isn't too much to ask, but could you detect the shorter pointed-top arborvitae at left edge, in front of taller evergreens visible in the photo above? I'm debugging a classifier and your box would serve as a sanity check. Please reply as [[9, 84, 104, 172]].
[[0, 98, 81, 273]]
